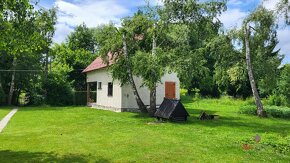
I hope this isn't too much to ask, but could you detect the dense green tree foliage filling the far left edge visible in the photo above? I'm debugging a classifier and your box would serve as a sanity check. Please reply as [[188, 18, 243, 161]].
[[0, 0, 56, 104]]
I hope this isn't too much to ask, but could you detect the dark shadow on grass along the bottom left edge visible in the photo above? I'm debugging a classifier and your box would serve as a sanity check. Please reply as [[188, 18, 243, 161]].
[[0, 150, 110, 163]]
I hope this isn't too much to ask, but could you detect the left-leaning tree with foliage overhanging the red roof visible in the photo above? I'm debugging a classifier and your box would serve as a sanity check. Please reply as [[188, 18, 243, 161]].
[[96, 23, 147, 112]]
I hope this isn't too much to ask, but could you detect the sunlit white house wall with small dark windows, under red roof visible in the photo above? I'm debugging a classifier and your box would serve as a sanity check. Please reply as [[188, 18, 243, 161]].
[[87, 69, 122, 108]]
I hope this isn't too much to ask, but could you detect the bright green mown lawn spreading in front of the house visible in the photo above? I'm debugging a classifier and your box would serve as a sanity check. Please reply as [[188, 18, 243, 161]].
[[0, 99, 290, 163]]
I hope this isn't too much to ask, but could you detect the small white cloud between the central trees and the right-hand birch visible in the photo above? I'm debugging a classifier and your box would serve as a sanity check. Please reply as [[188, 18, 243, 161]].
[[219, 8, 248, 29]]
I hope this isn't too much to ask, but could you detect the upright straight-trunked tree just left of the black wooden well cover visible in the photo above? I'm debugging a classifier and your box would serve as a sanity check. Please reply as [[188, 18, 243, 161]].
[[127, 10, 168, 116]]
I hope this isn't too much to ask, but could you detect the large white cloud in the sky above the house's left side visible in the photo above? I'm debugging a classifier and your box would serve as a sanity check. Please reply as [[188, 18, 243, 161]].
[[54, 0, 130, 43]]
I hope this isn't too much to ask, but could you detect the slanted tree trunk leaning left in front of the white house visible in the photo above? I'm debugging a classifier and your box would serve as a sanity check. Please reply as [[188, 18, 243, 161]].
[[123, 34, 148, 113]]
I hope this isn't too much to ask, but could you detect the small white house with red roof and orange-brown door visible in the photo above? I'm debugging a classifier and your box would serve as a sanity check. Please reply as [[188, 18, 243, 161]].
[[83, 55, 180, 112]]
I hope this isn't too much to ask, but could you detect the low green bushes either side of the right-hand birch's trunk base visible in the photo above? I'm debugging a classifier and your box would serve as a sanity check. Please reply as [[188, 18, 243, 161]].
[[239, 105, 290, 118]]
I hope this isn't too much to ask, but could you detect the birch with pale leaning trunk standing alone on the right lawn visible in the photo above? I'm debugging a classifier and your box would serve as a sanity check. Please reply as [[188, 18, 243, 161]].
[[242, 6, 282, 117]]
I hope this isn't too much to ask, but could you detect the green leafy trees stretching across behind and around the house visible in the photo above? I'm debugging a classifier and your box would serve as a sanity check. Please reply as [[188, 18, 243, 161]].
[[0, 0, 290, 110]]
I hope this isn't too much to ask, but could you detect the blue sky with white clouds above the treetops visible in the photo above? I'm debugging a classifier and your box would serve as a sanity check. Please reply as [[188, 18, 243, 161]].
[[39, 0, 290, 64]]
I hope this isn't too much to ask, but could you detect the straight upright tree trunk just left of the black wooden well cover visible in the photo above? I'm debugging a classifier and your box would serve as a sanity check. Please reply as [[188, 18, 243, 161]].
[[149, 24, 156, 117]]
